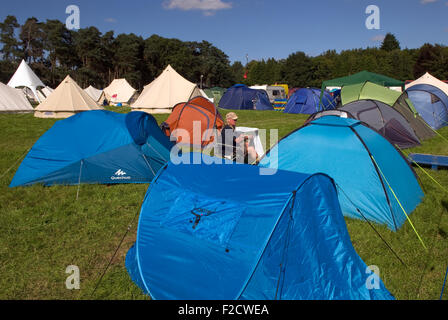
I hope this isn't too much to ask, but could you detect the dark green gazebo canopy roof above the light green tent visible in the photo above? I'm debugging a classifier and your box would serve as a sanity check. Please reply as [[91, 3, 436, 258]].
[[322, 71, 404, 90]]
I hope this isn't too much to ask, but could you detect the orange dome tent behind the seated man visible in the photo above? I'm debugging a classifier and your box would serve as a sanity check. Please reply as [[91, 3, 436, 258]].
[[161, 96, 224, 147]]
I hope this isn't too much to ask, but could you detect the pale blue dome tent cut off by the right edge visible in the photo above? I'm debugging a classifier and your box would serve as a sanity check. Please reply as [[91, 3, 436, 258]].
[[406, 84, 448, 130]]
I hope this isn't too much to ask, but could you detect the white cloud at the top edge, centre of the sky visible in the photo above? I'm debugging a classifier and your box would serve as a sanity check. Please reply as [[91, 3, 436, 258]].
[[163, 0, 232, 16]]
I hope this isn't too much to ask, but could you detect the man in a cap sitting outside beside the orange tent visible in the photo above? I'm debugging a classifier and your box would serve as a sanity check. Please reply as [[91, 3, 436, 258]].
[[220, 112, 258, 163]]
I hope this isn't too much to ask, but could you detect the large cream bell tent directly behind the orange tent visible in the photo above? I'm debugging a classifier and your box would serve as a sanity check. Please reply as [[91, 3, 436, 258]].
[[131, 65, 207, 113]]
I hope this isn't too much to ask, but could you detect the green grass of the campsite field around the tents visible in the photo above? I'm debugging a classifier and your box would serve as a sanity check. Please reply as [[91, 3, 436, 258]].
[[0, 108, 448, 300]]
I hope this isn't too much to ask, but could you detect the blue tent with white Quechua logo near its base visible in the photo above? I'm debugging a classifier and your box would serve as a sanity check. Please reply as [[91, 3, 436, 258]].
[[10, 110, 172, 187]]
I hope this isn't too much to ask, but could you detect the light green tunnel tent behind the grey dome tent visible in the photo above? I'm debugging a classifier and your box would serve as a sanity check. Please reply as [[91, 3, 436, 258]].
[[341, 82, 434, 140]]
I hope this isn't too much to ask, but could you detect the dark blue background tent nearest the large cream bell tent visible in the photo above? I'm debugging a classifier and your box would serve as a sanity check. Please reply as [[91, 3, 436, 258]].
[[219, 84, 274, 110]]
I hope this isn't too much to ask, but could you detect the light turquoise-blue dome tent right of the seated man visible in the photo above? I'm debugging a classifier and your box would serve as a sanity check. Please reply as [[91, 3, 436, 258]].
[[259, 116, 423, 231]]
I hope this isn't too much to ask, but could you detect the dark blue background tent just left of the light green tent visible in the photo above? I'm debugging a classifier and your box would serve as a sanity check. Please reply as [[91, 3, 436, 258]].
[[283, 88, 337, 114]]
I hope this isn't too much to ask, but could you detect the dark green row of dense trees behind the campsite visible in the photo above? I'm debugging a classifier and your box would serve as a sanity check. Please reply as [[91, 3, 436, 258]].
[[0, 16, 448, 90]]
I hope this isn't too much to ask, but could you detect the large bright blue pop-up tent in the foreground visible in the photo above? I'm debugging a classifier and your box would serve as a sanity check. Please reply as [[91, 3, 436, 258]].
[[126, 155, 393, 300]]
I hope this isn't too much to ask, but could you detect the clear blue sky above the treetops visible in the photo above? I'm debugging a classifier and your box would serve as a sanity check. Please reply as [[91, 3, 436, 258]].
[[0, 0, 448, 63]]
